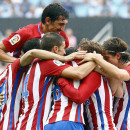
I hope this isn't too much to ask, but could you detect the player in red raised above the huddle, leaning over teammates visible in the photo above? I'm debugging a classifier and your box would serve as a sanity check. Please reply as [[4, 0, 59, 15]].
[[0, 3, 69, 63]]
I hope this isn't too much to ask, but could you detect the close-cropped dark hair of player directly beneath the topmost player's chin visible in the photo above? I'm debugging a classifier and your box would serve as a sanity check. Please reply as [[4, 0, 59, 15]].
[[41, 32, 65, 51]]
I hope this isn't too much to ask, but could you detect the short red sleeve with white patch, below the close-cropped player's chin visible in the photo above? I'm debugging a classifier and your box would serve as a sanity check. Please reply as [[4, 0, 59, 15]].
[[41, 60, 70, 76]]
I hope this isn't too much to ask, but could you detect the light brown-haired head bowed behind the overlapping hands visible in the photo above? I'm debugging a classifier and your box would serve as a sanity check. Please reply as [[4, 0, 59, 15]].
[[77, 38, 103, 54]]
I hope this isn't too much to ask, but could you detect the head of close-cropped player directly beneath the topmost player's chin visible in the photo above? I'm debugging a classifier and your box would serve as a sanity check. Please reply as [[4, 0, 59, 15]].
[[41, 32, 65, 55]]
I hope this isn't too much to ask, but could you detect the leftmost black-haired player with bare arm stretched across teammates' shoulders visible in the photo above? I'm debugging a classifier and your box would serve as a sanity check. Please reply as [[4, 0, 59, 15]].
[[0, 38, 78, 129]]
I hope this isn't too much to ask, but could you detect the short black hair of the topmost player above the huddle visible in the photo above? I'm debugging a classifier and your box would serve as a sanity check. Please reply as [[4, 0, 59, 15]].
[[41, 3, 69, 24]]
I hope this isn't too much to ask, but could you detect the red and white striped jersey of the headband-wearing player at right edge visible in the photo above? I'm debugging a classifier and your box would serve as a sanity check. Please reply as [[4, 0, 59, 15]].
[[114, 65, 130, 130]]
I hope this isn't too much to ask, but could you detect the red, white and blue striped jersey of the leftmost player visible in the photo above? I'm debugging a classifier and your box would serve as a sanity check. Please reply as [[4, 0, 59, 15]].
[[0, 59, 25, 130]]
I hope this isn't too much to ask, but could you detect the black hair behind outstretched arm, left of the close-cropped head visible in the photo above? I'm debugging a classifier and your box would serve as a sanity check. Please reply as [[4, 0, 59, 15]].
[[22, 38, 41, 53]]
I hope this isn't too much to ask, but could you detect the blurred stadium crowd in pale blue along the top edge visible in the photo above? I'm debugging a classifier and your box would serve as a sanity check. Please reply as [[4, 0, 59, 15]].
[[0, 0, 130, 18]]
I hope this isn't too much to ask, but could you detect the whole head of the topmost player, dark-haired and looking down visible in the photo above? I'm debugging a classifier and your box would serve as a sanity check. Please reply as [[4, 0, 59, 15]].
[[41, 3, 69, 33]]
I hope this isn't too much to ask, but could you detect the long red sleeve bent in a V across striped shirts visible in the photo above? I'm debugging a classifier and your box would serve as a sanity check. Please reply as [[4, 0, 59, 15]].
[[58, 72, 101, 104]]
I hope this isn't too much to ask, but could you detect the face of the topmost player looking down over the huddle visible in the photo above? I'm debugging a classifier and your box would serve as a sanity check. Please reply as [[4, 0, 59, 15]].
[[48, 16, 68, 34]]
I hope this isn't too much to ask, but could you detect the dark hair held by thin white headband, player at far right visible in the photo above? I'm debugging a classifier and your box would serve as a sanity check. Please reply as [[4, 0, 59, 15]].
[[103, 37, 130, 63]]
